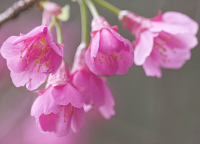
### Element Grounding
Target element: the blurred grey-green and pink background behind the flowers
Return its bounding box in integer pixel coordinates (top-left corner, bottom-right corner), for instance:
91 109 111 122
0 0 200 144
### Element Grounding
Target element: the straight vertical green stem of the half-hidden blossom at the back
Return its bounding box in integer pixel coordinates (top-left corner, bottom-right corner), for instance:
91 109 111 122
80 1 89 45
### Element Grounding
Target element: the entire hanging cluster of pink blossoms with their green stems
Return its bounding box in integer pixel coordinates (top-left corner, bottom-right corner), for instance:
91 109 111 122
1 0 198 137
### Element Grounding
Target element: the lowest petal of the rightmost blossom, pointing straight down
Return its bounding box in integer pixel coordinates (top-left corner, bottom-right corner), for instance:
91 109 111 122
143 56 162 78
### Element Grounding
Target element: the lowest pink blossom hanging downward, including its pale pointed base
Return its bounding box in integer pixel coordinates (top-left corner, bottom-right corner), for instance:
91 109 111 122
31 62 85 137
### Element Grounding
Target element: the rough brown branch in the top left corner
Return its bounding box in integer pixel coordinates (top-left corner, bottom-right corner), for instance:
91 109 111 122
0 0 40 26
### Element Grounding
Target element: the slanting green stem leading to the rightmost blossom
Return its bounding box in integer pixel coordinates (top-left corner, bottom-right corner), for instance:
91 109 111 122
93 0 121 16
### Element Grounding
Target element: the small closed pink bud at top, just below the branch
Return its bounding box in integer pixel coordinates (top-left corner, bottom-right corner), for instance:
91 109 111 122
40 1 62 26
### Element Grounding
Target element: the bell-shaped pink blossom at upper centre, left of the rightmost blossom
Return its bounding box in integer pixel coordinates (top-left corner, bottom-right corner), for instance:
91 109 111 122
85 16 134 76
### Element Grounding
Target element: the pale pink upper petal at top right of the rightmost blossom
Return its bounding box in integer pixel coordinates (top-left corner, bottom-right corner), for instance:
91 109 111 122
162 11 199 35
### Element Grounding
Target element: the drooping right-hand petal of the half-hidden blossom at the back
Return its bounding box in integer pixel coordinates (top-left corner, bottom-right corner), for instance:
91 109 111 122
99 84 115 119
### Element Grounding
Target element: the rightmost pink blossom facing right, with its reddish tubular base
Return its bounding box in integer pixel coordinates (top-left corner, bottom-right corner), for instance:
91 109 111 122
119 11 198 78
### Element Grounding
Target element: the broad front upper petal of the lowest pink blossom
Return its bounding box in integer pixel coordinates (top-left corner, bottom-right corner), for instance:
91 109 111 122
52 83 84 108
